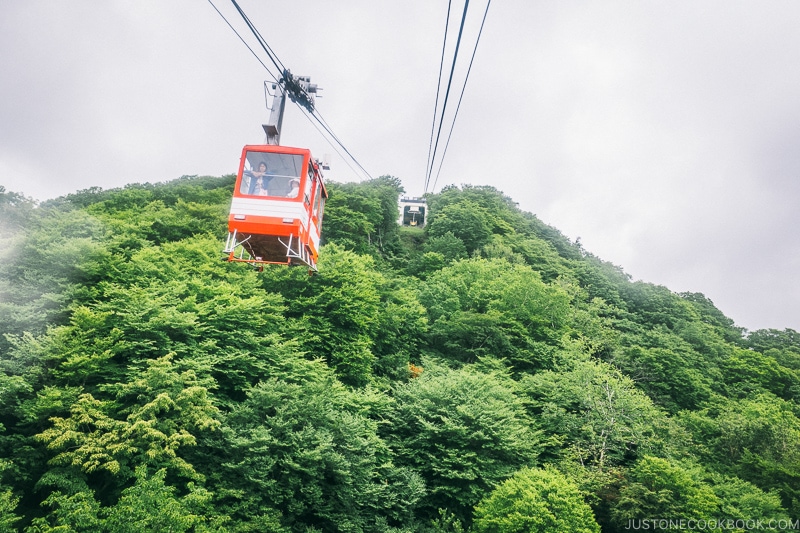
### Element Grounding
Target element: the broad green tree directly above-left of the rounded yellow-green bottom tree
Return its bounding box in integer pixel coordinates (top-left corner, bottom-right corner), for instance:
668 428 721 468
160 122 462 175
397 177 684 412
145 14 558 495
385 360 539 523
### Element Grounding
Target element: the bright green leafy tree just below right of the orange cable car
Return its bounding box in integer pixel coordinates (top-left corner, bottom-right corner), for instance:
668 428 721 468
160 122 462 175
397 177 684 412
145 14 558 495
263 244 428 386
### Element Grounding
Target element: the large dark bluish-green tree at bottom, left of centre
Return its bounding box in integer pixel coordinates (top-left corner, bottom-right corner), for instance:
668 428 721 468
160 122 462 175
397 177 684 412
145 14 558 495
212 370 424 531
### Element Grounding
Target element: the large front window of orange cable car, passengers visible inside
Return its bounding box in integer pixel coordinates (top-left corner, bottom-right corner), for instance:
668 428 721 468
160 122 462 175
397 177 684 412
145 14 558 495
239 152 303 198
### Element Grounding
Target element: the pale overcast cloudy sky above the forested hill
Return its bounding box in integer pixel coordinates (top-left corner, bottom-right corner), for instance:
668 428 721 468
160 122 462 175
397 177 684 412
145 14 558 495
0 0 800 330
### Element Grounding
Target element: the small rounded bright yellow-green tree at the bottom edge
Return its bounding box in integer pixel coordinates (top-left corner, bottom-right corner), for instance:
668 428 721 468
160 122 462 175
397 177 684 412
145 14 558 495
472 468 600 533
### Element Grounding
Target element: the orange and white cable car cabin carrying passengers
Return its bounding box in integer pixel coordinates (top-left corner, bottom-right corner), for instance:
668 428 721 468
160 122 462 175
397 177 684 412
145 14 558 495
225 144 328 272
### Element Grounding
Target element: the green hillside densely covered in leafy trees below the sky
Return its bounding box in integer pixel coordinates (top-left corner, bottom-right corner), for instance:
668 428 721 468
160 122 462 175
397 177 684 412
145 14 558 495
0 176 800 532
